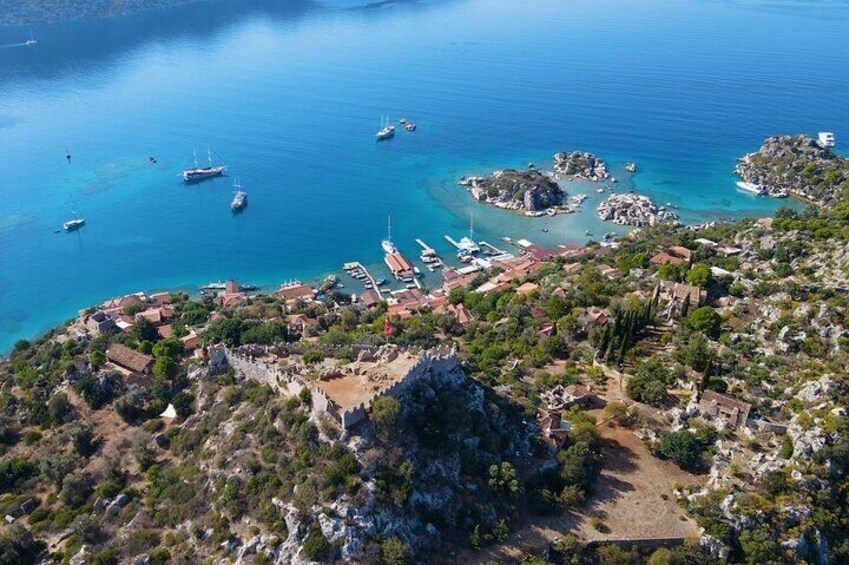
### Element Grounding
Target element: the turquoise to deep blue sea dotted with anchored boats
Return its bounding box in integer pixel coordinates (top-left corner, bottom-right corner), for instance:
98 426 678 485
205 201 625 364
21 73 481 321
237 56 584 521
0 0 849 351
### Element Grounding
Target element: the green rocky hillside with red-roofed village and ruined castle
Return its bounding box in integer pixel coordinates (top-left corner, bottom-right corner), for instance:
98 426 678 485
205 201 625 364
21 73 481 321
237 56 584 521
0 139 849 564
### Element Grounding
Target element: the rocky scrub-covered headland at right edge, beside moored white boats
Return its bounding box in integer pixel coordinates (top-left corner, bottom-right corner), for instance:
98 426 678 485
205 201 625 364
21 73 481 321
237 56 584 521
736 135 849 206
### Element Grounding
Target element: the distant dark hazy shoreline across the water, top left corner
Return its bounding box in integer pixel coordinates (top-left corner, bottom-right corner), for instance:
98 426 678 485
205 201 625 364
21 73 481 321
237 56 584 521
0 0 207 26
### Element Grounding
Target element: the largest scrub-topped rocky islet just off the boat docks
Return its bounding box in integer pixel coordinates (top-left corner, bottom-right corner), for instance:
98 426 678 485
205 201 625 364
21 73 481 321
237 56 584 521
460 169 565 212
